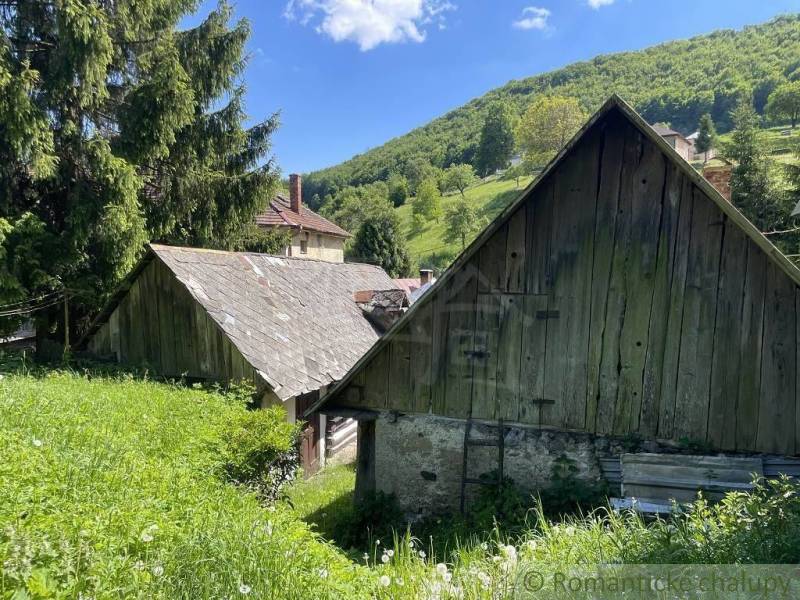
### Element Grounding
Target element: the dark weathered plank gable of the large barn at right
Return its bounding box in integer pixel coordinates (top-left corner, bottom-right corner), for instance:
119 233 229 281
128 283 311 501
336 112 800 455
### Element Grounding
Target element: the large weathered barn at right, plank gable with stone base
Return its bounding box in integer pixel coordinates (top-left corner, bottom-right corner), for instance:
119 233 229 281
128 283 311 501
312 97 800 513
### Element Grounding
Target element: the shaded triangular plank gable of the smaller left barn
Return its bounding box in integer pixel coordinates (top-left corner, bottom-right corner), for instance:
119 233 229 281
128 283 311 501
88 258 258 384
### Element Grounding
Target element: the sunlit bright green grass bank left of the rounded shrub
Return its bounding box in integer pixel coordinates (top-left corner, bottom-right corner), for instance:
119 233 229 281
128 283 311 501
0 374 371 598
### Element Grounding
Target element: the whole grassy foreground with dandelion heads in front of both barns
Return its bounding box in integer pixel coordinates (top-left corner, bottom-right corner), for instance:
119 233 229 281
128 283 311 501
0 370 800 600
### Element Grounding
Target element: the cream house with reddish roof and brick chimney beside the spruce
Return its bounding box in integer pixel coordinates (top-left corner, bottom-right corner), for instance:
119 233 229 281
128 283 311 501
256 175 350 263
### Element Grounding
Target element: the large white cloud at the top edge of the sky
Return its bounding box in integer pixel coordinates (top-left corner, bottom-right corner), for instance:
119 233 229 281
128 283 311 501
283 0 456 51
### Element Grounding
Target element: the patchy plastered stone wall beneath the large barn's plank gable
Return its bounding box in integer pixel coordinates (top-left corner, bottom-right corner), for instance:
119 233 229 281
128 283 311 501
374 412 625 517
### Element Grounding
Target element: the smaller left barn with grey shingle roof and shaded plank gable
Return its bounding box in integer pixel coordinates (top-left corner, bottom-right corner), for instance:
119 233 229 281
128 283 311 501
79 244 396 472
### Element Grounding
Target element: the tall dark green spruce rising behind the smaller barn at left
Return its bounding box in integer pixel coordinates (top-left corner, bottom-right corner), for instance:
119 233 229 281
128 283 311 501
0 0 277 340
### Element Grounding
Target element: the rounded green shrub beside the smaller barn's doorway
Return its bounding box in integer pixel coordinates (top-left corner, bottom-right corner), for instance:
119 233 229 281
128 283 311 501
219 406 300 502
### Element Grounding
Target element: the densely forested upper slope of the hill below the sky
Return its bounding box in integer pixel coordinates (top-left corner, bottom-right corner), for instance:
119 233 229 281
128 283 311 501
304 15 800 202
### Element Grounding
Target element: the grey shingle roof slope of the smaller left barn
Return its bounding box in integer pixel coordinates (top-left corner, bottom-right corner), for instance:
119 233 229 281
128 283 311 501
150 244 396 400
